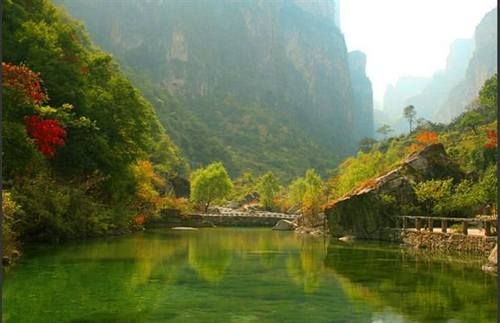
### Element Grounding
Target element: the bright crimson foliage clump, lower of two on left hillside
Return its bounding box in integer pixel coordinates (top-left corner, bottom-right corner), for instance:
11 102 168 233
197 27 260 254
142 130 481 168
26 116 66 158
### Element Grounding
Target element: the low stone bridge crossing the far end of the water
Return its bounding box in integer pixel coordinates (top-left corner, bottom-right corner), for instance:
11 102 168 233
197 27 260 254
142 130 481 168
149 211 298 227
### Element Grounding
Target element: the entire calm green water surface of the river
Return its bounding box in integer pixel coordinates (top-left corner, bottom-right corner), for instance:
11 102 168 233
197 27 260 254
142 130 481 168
3 228 497 322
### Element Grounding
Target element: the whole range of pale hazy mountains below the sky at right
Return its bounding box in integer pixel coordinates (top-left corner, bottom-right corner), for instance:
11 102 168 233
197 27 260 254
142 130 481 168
383 8 497 133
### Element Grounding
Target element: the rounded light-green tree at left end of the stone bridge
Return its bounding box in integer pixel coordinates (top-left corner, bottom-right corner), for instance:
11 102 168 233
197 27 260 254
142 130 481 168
191 162 233 213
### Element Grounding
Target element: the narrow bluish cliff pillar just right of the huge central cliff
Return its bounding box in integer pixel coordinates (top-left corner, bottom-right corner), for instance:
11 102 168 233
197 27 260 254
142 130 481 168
349 51 374 141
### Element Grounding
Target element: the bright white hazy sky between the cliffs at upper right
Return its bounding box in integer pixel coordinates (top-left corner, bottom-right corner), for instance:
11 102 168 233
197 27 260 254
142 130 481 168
340 0 496 102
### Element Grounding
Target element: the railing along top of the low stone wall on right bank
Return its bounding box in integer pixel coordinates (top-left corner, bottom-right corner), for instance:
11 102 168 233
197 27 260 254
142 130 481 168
397 215 497 236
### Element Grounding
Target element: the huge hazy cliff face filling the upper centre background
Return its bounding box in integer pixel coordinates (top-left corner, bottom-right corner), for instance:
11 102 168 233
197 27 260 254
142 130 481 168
58 0 371 177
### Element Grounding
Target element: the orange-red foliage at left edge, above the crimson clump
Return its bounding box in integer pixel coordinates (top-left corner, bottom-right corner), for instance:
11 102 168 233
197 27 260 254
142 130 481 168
2 63 48 104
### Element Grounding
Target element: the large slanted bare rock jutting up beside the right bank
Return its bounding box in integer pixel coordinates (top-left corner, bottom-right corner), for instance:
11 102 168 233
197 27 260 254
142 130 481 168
325 144 463 240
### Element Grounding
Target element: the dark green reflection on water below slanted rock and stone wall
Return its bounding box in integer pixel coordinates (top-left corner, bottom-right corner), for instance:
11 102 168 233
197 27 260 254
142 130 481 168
325 243 497 322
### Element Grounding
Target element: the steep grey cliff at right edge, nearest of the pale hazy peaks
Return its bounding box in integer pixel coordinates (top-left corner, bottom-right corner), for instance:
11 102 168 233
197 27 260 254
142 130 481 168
435 8 498 122
